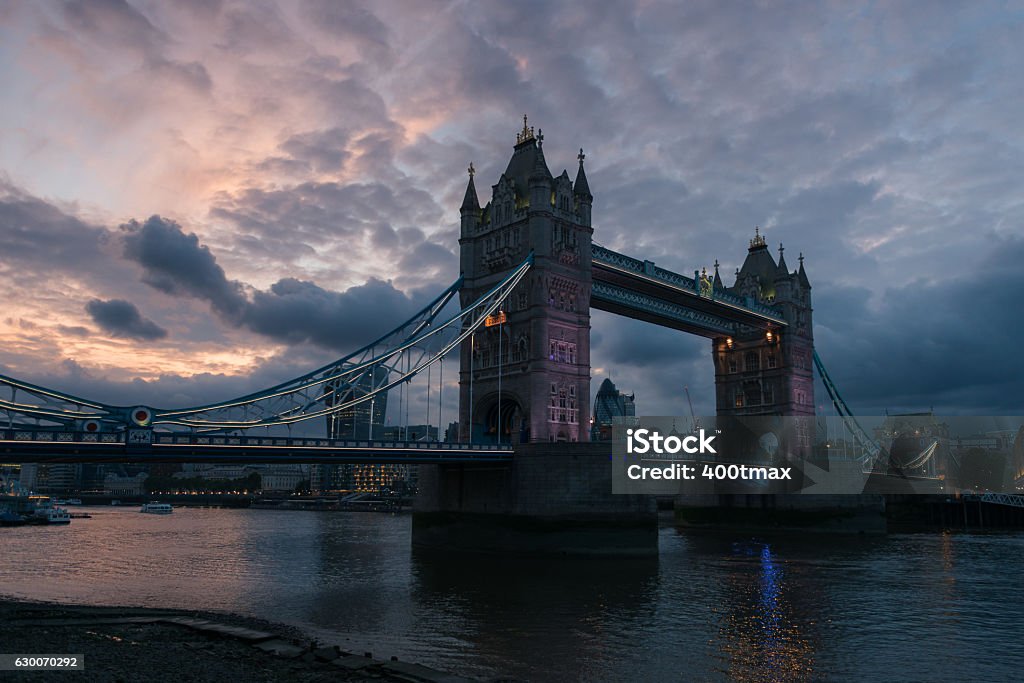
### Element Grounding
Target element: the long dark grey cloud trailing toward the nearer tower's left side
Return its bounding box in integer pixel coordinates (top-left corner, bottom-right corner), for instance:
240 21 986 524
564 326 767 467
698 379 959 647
123 216 426 350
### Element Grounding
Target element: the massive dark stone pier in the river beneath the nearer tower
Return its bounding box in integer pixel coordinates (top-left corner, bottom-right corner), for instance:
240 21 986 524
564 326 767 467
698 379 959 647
413 442 657 556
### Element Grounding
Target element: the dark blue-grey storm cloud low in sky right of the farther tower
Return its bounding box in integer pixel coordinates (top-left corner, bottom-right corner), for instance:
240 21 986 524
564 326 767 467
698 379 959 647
812 238 1024 415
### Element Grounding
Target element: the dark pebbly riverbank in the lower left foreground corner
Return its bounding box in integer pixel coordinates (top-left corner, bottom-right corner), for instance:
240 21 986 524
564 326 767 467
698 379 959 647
0 599 470 683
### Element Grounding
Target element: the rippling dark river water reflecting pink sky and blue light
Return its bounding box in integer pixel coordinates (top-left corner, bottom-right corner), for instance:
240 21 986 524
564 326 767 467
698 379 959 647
0 507 1024 681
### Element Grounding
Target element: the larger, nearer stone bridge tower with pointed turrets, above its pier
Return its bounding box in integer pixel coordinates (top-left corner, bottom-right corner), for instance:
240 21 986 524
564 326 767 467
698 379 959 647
459 117 594 443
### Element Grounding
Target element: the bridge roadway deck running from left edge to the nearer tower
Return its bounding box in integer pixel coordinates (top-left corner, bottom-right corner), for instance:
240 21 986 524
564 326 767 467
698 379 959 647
0 428 512 465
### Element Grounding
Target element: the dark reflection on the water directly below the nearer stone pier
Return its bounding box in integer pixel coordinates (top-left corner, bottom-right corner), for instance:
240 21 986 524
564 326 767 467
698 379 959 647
411 548 658 680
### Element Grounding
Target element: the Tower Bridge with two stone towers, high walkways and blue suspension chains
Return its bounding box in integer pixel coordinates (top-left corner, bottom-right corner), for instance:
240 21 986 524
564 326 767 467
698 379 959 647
0 117 880 547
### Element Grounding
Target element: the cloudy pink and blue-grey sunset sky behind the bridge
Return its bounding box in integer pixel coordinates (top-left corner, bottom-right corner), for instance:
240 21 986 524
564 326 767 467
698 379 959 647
0 0 1024 422
